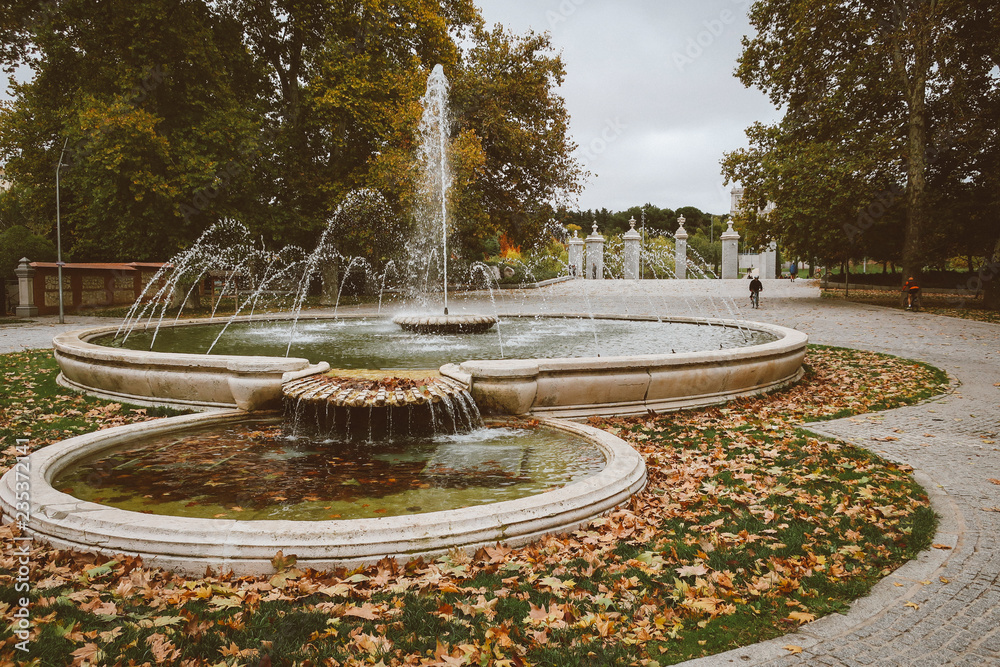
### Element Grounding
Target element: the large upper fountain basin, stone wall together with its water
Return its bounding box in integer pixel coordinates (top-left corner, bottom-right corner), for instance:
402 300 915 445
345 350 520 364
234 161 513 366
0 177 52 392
53 315 807 417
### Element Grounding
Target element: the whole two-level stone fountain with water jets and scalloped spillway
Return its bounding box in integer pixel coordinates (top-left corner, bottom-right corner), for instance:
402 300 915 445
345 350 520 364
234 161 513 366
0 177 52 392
0 68 806 575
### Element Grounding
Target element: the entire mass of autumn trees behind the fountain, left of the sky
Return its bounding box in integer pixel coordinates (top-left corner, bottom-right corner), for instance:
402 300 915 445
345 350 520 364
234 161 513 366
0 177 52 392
0 0 581 261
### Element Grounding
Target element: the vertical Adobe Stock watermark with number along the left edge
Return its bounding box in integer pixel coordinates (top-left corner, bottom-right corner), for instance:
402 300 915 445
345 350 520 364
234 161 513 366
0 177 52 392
11 438 31 653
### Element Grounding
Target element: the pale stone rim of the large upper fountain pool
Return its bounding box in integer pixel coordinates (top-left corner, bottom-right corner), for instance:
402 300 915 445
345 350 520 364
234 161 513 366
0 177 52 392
53 313 808 418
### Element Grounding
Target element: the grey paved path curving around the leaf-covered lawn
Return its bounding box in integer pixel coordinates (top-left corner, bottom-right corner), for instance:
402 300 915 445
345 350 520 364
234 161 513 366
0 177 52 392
0 281 1000 667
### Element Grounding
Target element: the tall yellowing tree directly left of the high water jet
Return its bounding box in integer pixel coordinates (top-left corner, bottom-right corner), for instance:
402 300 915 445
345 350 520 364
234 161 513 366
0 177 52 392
222 0 480 255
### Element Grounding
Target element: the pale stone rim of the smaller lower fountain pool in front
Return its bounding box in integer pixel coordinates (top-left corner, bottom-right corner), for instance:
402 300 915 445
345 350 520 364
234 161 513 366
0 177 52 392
0 411 646 575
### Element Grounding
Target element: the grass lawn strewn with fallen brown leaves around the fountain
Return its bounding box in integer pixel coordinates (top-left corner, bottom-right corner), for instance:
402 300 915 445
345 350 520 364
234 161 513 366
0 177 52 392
0 346 948 667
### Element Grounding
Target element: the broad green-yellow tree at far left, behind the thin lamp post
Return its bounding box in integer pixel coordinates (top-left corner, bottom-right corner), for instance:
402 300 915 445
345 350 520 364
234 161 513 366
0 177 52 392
0 0 253 260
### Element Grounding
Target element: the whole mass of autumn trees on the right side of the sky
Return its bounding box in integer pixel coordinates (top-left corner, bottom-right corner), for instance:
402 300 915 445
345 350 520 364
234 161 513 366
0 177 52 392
723 0 1000 302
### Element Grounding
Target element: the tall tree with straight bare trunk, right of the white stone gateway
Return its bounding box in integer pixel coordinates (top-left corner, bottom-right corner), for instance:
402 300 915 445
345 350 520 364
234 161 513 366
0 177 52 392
723 0 996 290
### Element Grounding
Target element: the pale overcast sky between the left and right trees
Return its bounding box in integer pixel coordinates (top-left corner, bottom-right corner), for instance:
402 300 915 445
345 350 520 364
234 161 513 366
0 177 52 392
477 0 780 213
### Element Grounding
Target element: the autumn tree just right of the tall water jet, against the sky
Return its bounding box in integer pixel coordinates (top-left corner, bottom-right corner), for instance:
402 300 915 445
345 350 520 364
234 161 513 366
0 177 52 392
451 26 583 252
